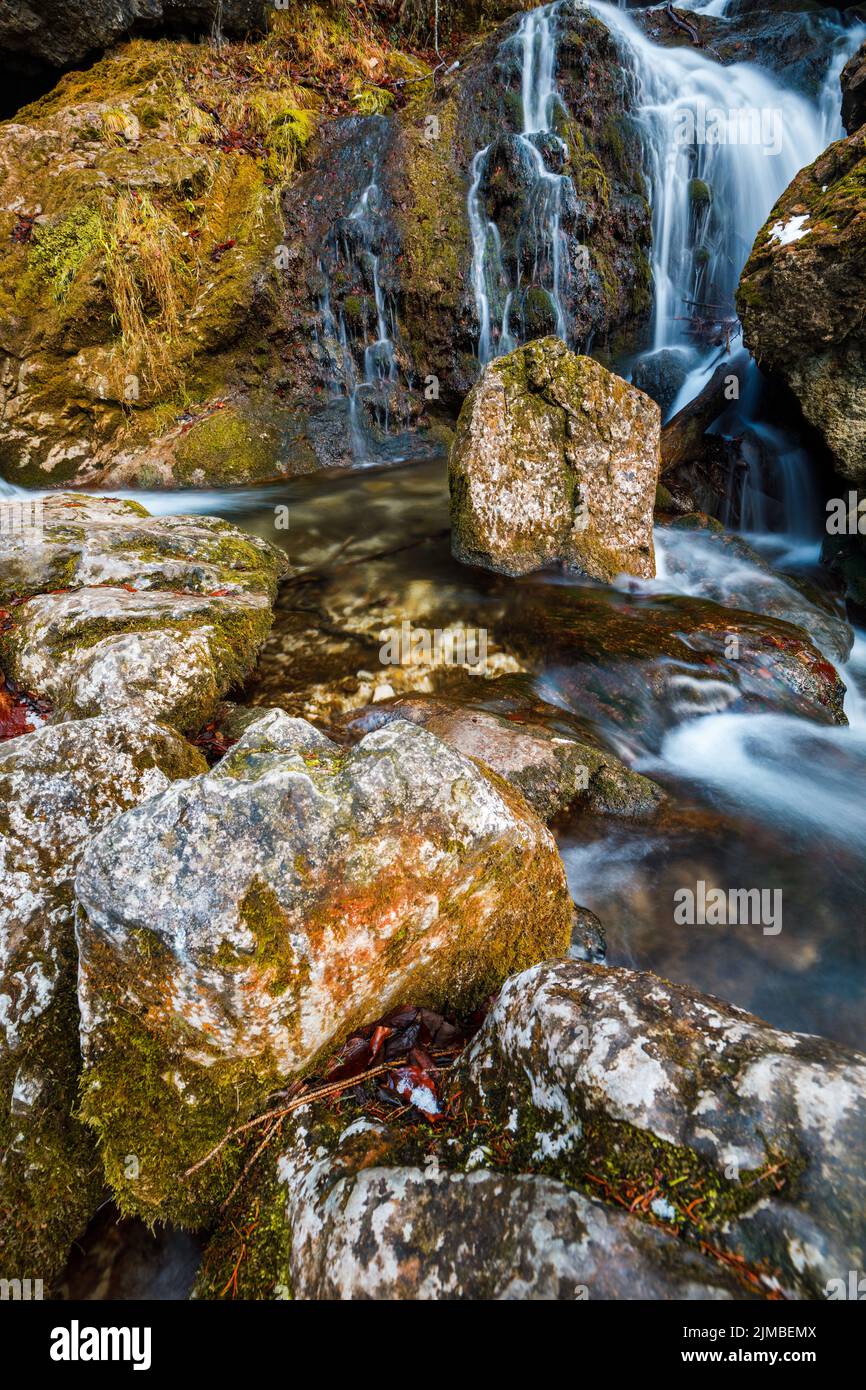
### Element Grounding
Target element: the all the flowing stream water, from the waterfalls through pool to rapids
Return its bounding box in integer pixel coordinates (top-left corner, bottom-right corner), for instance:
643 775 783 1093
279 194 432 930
3 0 866 1047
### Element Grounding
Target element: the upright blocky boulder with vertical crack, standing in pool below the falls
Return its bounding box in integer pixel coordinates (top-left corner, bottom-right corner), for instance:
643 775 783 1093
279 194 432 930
449 338 659 580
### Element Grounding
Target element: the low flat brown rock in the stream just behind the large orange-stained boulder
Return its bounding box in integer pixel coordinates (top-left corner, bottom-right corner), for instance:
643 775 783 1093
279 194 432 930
341 695 663 821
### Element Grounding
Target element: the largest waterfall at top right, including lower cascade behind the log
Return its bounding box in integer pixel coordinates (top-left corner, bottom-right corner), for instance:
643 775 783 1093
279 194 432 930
585 0 866 534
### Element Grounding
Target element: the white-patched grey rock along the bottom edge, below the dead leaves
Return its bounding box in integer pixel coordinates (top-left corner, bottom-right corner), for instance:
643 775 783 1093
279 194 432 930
197 1116 744 1301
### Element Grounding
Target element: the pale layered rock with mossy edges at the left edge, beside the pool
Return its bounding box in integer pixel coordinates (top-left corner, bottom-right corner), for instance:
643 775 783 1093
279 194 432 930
0 496 286 730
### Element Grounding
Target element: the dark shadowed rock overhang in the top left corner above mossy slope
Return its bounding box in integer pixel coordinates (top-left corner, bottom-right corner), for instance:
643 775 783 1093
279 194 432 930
0 0 268 71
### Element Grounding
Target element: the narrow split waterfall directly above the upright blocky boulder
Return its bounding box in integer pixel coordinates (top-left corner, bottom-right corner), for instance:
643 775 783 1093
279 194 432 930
467 0 569 366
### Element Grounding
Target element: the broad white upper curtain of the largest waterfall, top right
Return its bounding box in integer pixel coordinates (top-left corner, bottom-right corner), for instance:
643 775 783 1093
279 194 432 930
588 0 838 358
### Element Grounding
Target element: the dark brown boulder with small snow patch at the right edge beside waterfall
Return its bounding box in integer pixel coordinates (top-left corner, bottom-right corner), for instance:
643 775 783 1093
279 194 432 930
737 135 866 482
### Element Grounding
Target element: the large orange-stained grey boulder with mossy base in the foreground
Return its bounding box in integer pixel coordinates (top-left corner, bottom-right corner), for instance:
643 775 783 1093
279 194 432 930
76 712 571 1225
